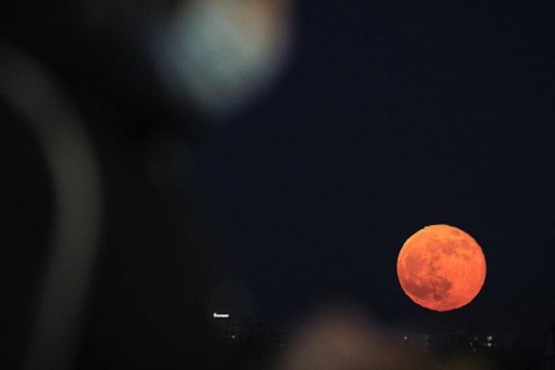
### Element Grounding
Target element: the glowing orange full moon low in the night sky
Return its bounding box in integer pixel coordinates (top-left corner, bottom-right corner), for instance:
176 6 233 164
397 225 486 312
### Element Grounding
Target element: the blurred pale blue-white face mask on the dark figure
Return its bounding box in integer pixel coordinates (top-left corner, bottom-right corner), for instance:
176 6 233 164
151 0 296 116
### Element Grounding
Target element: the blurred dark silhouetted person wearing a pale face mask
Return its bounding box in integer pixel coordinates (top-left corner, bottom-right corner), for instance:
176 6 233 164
0 0 294 370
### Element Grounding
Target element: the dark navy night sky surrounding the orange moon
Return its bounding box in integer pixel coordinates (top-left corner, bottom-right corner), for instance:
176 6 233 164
192 0 555 342
